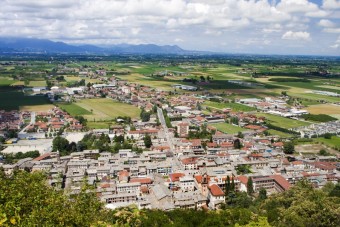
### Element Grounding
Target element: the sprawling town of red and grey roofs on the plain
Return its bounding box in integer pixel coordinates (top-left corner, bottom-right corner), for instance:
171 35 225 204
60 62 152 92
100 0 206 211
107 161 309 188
0 56 340 210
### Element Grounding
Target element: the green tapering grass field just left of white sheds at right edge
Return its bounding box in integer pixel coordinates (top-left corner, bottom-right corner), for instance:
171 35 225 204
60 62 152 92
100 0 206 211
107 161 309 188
256 113 310 129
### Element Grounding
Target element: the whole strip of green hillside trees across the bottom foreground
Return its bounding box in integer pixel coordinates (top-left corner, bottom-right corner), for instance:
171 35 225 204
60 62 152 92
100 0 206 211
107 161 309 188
0 171 340 227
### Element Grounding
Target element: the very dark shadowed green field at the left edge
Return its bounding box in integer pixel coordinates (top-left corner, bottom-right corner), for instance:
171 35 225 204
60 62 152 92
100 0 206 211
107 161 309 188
0 88 50 110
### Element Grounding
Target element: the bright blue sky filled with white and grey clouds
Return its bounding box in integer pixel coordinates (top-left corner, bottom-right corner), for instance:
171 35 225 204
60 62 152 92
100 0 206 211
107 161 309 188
0 0 340 55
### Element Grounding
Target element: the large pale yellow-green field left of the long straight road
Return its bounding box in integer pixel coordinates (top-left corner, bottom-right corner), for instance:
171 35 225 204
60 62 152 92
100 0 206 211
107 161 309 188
74 98 140 121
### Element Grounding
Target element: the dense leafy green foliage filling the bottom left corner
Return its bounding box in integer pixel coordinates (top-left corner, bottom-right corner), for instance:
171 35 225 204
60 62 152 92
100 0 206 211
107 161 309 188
0 171 108 226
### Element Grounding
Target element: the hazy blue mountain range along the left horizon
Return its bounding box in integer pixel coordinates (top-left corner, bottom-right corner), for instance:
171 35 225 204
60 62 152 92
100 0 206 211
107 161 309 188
0 38 202 54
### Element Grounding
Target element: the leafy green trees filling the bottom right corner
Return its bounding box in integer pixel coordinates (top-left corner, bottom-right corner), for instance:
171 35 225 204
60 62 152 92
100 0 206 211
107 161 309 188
260 180 340 226
